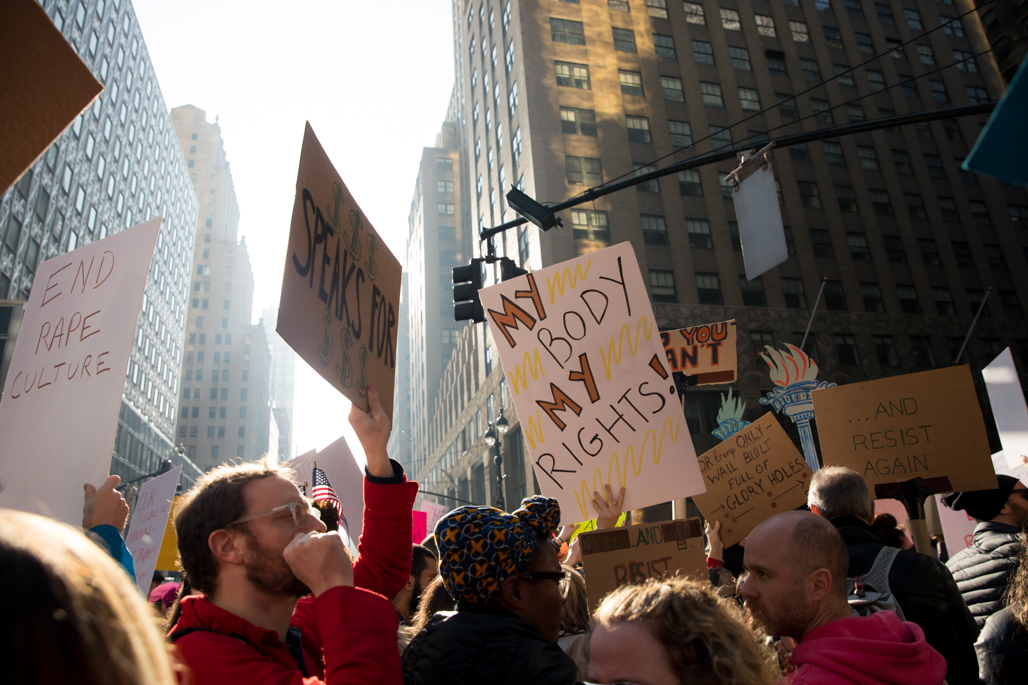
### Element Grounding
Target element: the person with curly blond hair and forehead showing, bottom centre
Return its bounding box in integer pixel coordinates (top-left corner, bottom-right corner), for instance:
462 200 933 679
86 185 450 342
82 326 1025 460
589 578 779 685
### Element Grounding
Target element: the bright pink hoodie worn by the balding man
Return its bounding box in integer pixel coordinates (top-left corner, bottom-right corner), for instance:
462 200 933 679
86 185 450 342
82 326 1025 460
779 611 946 685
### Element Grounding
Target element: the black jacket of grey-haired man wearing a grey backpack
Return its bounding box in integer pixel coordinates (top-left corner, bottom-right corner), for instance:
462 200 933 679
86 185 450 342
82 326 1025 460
832 516 979 685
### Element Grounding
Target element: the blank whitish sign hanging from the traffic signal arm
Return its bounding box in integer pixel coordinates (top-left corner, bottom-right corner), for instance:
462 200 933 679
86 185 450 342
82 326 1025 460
732 157 788 281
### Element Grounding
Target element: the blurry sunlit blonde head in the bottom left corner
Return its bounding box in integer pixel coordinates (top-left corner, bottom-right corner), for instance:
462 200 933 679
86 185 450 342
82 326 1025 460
0 509 177 685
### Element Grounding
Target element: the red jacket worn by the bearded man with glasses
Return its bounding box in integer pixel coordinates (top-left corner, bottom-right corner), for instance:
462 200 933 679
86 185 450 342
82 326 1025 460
170 475 417 685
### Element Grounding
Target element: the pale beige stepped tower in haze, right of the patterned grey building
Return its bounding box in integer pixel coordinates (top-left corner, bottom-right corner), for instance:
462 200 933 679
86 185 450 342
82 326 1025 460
172 105 279 469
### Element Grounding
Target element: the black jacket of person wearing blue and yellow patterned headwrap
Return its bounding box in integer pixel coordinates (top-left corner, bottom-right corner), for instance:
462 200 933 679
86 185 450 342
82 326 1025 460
402 605 578 685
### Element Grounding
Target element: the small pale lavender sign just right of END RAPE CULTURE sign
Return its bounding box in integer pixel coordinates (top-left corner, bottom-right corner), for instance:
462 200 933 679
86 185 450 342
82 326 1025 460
125 466 182 597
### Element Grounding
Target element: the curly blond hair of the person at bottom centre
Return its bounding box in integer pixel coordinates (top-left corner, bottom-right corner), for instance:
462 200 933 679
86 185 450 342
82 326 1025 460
593 577 778 685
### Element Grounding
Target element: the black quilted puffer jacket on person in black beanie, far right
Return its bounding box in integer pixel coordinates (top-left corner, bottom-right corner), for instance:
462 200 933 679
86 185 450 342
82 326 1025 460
946 521 1021 628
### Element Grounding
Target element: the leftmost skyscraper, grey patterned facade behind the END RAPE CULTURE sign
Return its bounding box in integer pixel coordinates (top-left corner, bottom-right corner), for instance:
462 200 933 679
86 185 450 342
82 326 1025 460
0 0 199 486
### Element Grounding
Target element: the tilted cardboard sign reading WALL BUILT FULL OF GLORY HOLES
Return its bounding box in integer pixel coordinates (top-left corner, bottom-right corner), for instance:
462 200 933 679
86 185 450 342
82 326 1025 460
693 411 810 547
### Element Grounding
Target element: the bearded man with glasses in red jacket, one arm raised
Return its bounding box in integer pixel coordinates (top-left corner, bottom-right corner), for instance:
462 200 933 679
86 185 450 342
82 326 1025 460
169 387 417 685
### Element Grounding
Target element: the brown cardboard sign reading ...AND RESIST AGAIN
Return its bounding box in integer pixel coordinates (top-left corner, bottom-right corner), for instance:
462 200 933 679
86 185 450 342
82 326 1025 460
811 366 997 499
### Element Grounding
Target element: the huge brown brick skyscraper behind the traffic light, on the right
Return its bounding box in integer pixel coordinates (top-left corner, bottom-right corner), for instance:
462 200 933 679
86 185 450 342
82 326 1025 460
411 0 1028 505
